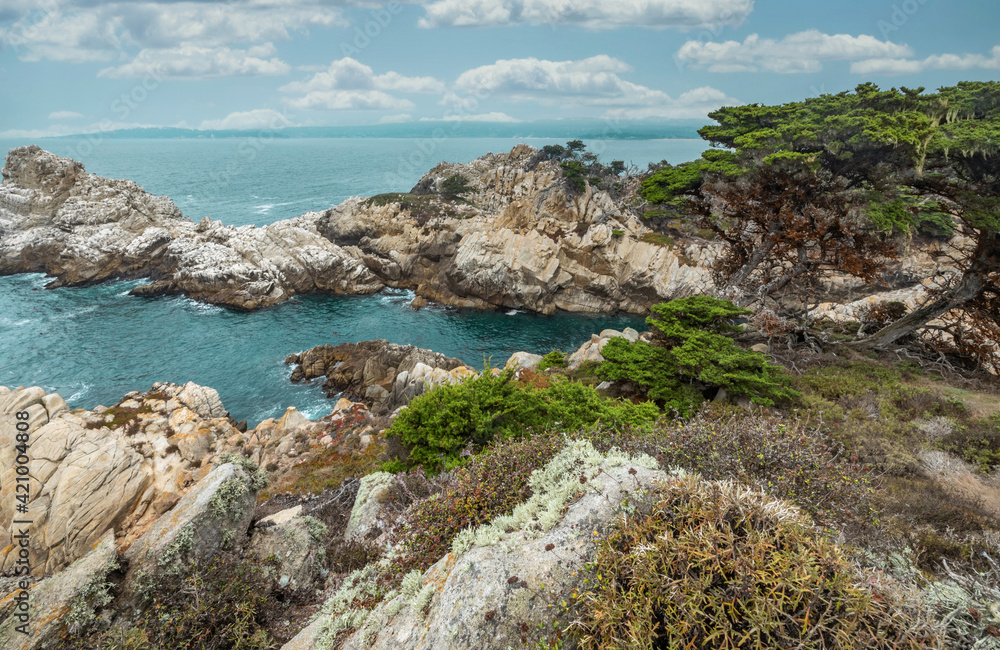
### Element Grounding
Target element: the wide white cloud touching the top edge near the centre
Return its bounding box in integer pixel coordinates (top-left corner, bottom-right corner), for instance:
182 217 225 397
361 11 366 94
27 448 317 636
418 0 754 29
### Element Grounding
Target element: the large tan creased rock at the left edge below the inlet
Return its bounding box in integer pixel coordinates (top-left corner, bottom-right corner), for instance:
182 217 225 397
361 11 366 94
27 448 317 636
0 384 250 575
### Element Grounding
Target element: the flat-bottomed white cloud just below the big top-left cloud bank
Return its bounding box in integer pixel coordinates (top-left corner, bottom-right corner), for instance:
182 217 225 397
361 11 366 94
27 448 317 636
97 43 292 79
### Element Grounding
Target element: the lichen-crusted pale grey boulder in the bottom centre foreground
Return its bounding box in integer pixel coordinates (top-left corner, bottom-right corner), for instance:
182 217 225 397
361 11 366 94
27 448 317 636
284 441 669 650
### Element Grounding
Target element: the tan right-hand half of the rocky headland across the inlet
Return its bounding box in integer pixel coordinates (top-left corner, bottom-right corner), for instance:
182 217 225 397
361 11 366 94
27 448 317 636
316 145 715 313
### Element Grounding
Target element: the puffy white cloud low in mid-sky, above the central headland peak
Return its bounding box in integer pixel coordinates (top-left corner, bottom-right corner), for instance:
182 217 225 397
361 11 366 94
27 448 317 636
454 54 670 106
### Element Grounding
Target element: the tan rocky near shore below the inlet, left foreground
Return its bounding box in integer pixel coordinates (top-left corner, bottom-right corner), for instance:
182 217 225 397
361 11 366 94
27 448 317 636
0 330 637 649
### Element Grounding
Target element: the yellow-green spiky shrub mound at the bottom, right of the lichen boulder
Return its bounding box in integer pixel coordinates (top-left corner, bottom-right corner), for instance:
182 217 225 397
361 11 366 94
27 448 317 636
570 475 935 650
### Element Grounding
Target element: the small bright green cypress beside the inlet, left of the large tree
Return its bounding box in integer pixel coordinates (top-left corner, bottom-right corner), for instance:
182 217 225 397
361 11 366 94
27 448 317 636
598 296 797 415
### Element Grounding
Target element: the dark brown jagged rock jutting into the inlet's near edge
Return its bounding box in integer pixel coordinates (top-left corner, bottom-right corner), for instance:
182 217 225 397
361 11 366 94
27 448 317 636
286 339 474 414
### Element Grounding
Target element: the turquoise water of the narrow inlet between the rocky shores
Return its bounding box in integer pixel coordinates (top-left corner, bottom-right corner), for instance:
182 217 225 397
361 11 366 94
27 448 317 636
0 274 642 424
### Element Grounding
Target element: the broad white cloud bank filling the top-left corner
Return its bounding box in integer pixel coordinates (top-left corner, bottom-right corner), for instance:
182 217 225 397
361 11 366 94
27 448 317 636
0 0 346 62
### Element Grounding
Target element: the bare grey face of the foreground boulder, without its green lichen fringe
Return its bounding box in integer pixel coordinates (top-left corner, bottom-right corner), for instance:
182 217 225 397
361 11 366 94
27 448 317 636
326 448 668 650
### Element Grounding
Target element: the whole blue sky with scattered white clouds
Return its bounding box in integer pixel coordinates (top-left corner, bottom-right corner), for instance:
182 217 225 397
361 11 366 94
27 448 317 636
0 0 1000 137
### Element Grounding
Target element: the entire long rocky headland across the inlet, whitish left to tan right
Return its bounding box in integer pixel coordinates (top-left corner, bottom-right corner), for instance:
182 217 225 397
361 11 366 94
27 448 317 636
0 145 714 313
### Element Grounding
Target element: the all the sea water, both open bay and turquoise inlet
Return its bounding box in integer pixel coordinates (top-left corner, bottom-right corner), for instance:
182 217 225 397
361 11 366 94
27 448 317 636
0 138 705 426
